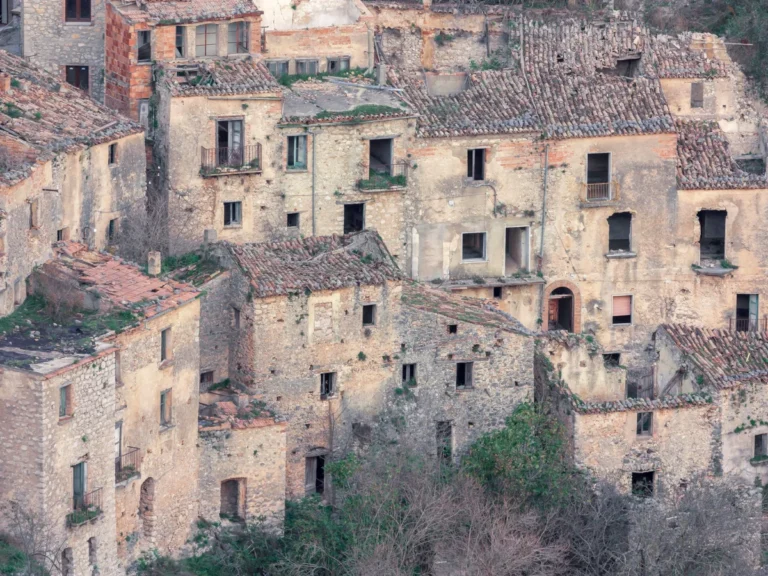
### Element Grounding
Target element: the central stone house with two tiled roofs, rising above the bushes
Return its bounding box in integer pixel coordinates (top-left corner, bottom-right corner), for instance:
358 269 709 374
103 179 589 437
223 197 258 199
201 231 533 498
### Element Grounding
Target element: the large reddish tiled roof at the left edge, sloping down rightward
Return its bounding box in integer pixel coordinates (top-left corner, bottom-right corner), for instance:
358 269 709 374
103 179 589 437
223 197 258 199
0 50 143 182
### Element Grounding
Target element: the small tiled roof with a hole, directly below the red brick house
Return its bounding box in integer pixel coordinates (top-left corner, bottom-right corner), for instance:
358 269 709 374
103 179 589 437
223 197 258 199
161 56 282 96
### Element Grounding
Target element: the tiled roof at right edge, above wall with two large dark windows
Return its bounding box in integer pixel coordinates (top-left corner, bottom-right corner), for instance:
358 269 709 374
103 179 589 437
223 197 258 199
675 120 768 190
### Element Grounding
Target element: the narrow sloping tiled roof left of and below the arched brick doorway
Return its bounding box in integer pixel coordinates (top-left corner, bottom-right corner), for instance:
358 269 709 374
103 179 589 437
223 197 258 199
402 282 530 335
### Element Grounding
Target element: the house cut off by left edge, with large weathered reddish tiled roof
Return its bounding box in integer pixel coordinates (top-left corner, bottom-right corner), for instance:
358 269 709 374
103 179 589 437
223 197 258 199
0 51 146 314
